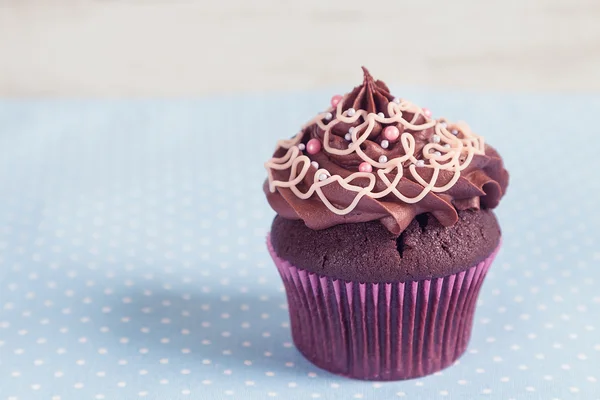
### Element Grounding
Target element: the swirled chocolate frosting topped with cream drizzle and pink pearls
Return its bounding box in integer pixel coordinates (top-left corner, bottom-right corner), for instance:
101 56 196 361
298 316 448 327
264 68 508 234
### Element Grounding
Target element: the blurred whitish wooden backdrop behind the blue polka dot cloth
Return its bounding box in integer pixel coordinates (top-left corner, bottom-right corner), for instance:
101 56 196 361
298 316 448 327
0 0 600 96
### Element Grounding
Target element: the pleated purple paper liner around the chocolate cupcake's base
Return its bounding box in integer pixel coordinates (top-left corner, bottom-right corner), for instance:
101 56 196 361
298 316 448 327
267 236 500 380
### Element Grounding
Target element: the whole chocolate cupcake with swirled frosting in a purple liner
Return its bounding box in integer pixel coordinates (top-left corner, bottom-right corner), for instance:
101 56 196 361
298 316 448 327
263 68 508 380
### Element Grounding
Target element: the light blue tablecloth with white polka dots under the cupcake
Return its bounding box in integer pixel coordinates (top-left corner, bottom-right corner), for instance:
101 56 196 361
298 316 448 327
0 89 600 400
